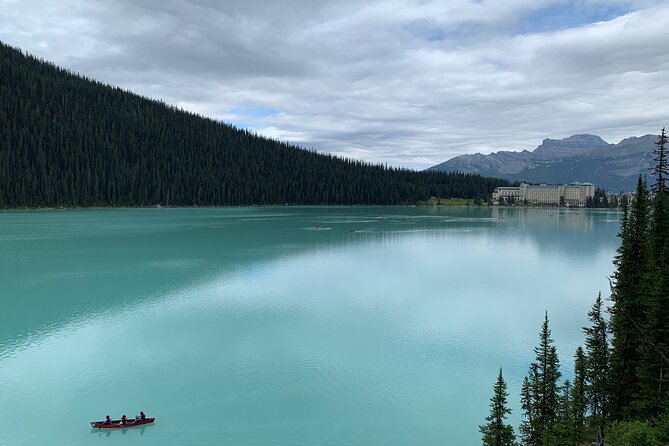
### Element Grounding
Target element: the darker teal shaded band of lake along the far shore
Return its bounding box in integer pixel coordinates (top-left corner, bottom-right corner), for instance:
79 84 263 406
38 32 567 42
0 207 618 358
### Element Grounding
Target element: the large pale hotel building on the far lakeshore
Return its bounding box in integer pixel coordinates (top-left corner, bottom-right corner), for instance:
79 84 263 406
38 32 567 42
492 183 595 208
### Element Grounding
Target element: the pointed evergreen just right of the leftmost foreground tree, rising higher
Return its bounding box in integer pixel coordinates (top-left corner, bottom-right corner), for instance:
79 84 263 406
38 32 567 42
521 313 561 446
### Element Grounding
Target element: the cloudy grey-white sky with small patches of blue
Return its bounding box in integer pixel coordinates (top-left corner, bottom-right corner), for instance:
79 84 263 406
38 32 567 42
0 0 669 169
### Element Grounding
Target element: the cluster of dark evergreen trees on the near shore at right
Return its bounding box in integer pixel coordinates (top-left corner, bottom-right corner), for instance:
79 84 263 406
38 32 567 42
480 128 669 446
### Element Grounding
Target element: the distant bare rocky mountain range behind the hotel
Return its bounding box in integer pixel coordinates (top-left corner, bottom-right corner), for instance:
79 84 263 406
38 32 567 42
427 134 657 192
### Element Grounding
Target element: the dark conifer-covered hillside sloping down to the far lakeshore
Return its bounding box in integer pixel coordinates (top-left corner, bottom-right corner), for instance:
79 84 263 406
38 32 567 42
0 42 506 208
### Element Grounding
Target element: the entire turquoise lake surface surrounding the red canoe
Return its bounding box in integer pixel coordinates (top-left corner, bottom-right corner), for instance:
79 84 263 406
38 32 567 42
0 207 619 446
